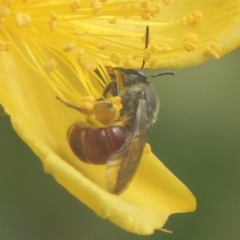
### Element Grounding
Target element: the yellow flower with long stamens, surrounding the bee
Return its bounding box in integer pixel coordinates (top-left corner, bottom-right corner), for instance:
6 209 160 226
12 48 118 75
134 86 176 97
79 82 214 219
0 0 240 234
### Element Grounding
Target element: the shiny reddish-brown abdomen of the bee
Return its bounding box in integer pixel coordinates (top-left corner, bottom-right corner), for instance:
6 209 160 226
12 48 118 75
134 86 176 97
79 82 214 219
68 123 126 165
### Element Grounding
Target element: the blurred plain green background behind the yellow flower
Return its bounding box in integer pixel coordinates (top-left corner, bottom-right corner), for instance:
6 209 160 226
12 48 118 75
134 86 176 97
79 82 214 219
0 50 240 240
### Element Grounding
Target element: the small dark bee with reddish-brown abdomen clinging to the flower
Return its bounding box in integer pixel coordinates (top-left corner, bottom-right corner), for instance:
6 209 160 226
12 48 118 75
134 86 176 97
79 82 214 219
58 27 174 195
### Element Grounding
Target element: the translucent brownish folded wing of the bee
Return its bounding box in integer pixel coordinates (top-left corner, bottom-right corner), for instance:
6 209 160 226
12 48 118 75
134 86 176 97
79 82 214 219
106 98 152 194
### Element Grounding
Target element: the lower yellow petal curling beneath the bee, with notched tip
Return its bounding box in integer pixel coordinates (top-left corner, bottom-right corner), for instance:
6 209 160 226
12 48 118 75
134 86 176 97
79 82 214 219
0 48 196 234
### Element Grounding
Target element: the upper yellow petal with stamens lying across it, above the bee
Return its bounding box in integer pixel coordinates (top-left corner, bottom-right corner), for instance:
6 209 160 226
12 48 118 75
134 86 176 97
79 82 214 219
0 0 240 70
